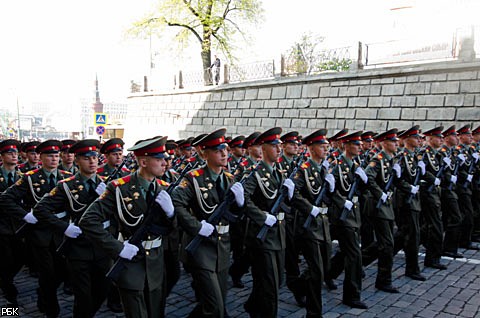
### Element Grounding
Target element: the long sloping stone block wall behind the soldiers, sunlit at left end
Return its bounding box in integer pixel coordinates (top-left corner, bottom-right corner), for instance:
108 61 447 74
125 60 480 144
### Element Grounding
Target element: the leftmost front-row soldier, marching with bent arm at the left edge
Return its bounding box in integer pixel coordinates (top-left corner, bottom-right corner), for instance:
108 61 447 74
0 140 70 317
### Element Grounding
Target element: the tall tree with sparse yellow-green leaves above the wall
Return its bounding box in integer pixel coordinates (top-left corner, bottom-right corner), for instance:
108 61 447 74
129 0 263 84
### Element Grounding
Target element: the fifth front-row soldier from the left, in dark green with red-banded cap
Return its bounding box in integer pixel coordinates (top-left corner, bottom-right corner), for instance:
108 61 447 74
244 127 295 318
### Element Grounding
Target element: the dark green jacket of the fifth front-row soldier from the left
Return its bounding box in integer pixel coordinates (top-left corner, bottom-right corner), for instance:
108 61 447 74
244 161 288 251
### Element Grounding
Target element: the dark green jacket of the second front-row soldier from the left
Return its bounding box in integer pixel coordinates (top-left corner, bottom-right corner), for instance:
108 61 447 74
33 172 106 261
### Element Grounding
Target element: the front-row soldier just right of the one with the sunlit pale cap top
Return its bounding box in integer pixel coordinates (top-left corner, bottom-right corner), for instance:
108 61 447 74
172 129 245 318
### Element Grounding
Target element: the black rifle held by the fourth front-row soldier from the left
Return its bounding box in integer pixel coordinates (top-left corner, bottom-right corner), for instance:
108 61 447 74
185 164 260 255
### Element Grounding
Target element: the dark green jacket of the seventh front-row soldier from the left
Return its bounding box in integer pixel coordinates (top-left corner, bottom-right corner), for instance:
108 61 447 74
328 154 363 229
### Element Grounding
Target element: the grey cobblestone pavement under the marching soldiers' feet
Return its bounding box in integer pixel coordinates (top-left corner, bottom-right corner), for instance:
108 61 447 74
0 249 480 318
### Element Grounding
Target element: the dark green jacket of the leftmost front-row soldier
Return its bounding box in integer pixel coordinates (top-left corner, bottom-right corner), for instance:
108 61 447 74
0 168 71 247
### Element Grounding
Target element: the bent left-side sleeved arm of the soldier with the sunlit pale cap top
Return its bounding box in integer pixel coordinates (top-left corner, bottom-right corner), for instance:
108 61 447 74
79 183 123 259
